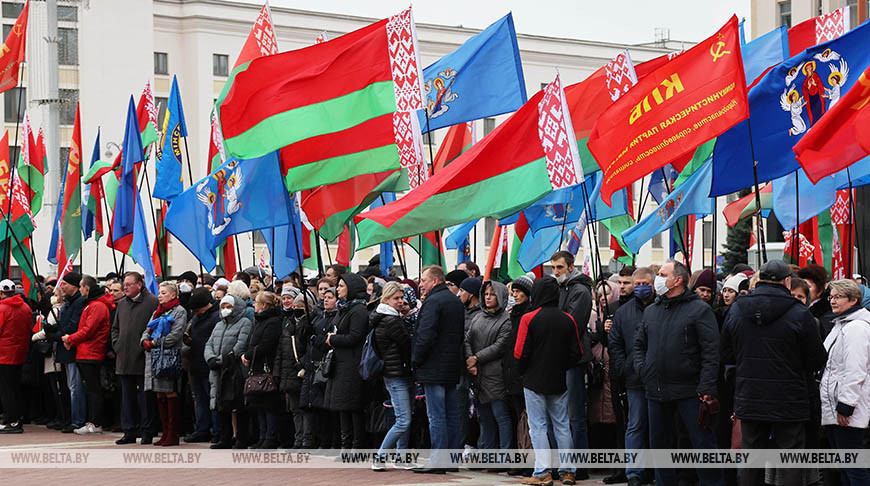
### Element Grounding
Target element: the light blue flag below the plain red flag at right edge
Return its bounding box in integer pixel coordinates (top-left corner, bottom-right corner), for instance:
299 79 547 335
772 157 870 230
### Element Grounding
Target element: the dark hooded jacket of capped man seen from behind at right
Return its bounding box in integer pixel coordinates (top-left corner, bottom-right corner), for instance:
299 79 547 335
720 282 826 422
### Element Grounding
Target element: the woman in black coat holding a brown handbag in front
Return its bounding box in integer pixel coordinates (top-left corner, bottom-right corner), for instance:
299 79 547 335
242 291 282 449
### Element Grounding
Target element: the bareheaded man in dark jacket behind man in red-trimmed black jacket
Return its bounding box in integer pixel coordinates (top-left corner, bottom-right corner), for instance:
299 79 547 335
550 251 592 460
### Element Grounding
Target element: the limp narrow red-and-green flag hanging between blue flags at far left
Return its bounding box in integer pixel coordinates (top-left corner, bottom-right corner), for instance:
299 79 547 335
60 105 82 258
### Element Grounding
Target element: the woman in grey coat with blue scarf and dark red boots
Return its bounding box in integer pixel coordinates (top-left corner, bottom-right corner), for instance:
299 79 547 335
140 282 187 446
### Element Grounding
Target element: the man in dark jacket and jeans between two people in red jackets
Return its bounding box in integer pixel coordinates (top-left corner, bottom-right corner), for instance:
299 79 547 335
46 272 87 434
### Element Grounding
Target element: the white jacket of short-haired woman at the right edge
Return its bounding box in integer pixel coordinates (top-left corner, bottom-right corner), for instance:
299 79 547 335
819 304 870 429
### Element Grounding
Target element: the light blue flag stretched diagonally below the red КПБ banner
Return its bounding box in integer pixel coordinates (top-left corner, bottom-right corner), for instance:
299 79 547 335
622 160 713 254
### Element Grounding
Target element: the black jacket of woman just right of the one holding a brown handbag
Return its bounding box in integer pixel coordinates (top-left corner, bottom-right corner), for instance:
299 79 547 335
272 309 316 393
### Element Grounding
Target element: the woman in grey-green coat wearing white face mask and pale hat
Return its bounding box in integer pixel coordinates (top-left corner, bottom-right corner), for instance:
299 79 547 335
203 295 251 449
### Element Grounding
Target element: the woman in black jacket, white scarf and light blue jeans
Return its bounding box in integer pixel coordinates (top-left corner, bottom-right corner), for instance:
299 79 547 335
370 282 414 471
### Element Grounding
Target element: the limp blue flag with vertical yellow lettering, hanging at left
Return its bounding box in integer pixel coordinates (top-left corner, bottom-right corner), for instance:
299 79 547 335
154 76 187 201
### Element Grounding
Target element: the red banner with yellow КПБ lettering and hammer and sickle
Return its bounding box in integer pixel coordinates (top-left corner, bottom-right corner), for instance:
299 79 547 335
588 16 749 204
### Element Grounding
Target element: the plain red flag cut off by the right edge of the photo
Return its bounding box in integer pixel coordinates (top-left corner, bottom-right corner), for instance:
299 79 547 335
793 67 870 184
